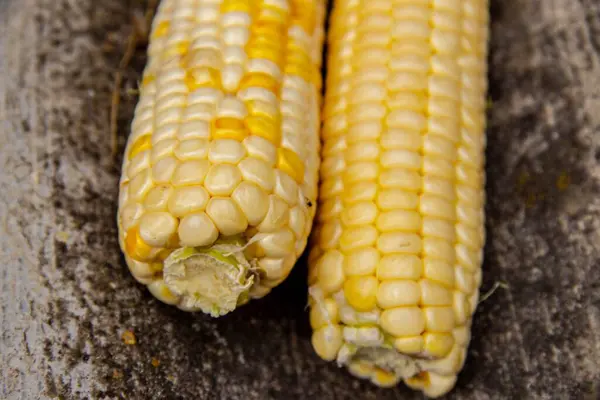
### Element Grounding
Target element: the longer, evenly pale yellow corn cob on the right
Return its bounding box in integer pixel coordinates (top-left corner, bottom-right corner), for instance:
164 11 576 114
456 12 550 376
309 0 488 397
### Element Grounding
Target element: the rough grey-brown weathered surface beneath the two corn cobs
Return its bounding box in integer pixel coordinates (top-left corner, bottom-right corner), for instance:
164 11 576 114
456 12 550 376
0 0 600 400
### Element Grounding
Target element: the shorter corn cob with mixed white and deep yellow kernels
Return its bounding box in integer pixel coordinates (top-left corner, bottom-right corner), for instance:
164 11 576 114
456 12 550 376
118 0 325 316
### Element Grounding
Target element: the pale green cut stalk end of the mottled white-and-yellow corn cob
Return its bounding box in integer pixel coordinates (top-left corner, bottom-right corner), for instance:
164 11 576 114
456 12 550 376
163 244 254 317
